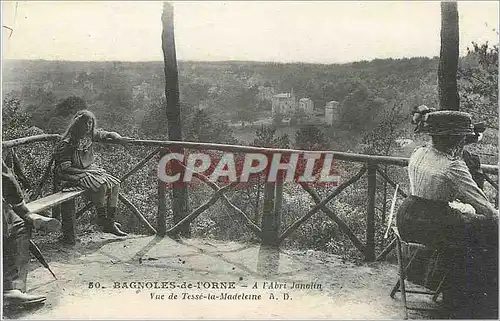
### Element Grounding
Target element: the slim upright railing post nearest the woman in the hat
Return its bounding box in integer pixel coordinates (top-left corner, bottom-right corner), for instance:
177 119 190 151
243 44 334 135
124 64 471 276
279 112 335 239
365 163 377 261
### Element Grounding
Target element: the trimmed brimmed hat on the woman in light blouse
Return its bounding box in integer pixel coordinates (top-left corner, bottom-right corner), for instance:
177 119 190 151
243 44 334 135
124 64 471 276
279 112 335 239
412 105 476 136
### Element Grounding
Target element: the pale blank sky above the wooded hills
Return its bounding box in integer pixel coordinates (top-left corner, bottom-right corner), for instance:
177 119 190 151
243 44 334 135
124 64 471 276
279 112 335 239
2 1 499 64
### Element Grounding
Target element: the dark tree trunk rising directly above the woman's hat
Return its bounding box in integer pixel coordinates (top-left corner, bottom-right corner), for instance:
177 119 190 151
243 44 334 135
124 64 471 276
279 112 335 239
438 2 460 110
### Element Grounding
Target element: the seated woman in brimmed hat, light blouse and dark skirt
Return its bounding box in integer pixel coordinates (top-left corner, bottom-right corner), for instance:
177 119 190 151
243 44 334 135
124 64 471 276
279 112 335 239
397 106 498 318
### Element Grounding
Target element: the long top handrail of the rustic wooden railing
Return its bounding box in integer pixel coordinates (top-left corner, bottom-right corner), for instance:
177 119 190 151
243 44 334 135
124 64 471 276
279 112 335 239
2 134 498 174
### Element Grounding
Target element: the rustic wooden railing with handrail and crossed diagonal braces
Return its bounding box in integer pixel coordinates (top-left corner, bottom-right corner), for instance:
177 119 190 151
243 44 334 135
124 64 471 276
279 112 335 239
2 135 498 261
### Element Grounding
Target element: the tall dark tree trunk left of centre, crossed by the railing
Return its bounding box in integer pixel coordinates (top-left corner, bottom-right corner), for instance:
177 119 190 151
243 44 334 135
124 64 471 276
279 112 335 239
160 2 190 237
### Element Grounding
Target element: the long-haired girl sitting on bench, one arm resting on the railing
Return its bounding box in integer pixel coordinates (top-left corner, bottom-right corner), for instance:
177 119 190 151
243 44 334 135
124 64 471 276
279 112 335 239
54 110 127 236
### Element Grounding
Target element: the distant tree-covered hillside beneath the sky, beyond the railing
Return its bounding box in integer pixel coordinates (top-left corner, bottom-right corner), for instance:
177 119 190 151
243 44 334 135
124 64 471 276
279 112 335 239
3 58 437 139
